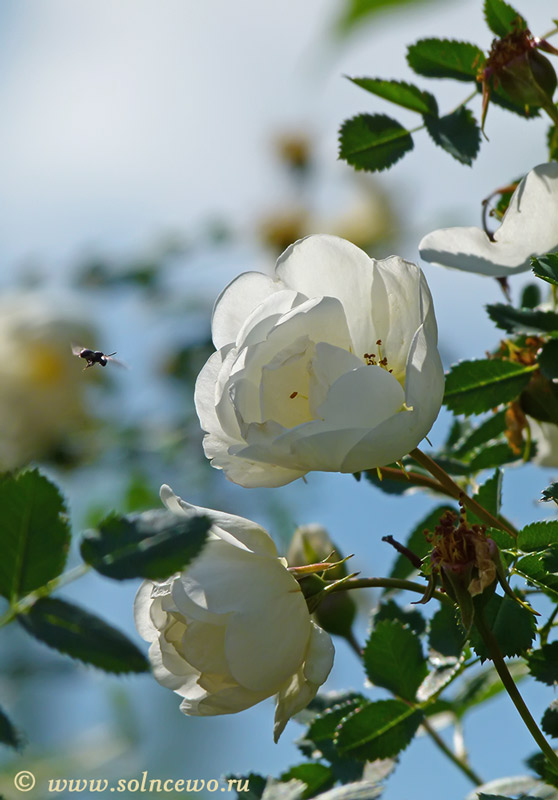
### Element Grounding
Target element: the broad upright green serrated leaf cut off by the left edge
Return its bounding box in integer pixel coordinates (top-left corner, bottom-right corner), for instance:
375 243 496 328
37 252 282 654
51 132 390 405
0 469 70 601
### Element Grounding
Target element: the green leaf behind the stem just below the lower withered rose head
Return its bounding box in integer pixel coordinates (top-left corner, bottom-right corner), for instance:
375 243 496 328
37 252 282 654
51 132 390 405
471 594 535 659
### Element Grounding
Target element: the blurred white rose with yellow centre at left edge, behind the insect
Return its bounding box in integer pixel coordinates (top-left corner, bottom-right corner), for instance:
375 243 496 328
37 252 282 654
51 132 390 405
0 292 91 470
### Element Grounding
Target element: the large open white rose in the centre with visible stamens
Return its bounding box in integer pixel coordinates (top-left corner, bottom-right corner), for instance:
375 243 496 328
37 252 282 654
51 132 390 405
195 235 444 487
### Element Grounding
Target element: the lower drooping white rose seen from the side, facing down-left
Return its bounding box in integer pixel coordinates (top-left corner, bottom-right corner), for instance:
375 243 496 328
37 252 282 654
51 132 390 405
134 486 334 741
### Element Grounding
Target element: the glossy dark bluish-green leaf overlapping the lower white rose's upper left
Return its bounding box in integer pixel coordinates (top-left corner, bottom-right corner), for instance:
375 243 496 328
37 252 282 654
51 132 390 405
81 510 211 580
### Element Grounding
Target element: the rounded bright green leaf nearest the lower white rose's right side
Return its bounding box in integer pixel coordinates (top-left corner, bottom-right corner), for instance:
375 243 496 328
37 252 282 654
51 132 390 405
363 620 428 701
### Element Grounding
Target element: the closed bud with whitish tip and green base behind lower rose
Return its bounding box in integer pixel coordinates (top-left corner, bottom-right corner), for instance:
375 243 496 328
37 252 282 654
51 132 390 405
287 523 357 637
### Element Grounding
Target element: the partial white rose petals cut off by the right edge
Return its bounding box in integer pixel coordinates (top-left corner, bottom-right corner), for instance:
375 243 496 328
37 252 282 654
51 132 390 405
419 161 558 278
